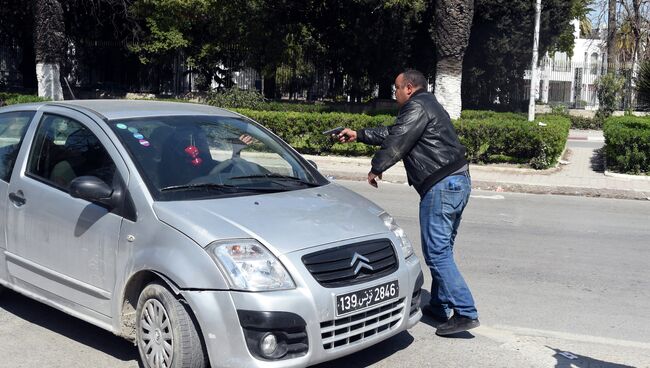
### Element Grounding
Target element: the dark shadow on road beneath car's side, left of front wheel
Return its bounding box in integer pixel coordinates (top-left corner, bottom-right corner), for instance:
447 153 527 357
0 290 141 366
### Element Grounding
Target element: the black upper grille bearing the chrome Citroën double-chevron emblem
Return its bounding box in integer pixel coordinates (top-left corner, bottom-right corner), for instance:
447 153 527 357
302 239 399 288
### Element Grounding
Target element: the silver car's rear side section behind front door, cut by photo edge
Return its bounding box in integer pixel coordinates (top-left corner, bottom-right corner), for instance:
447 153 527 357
0 111 36 281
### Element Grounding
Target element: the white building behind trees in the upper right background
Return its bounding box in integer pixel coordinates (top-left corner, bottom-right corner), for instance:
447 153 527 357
524 20 607 109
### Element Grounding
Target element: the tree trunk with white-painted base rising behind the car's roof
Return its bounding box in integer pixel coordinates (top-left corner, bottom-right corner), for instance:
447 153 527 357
34 0 66 101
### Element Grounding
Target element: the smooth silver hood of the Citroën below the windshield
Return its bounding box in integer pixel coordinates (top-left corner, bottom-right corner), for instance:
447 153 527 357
153 183 388 254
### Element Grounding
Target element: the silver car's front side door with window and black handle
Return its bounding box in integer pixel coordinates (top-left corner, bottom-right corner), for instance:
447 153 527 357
6 106 128 317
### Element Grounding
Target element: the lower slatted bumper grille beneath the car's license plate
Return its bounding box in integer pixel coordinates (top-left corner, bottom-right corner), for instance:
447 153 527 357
320 298 404 350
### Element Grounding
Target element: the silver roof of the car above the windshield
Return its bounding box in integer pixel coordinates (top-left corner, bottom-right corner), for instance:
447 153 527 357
2 100 240 120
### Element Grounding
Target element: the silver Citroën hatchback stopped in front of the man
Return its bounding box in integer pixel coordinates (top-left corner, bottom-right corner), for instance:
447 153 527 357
0 100 423 368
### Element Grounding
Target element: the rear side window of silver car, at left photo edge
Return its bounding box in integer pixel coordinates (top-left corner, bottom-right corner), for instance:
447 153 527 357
0 111 36 182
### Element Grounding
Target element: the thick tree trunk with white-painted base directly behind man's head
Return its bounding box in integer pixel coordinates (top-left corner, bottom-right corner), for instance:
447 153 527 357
434 0 474 119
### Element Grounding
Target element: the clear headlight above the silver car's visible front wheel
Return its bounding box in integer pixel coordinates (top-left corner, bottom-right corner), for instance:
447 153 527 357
207 239 296 291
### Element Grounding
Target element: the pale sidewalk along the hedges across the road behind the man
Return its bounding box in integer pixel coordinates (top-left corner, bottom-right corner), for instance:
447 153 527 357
305 130 650 200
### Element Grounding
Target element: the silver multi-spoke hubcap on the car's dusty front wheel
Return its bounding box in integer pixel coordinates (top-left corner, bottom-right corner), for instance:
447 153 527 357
138 299 174 368
